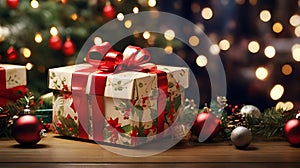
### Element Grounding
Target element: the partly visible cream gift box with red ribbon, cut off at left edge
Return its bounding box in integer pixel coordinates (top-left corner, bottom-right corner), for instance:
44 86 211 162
0 64 28 106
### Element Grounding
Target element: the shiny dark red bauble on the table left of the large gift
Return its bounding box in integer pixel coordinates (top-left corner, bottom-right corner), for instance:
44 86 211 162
12 115 43 146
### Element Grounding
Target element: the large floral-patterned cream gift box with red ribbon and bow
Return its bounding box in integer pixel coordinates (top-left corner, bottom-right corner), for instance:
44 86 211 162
49 42 189 146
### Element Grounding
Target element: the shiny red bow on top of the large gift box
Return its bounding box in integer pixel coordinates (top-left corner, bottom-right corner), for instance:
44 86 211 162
86 42 156 72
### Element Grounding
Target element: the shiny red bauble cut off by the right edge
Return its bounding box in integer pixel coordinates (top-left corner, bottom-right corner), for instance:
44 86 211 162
284 113 300 146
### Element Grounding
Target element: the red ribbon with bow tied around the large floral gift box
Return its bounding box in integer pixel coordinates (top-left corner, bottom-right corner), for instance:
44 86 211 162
72 42 168 141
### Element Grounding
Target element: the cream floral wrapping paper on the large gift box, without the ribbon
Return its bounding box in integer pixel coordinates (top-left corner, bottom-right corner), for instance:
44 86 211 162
49 64 189 146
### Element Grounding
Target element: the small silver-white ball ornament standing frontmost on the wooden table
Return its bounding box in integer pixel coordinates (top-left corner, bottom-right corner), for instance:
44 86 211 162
230 126 252 148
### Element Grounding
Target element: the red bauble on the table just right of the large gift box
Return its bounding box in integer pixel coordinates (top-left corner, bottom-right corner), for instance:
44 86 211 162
192 112 221 142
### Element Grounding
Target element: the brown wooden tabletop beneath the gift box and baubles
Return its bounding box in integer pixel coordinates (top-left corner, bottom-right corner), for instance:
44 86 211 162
0 133 300 168
